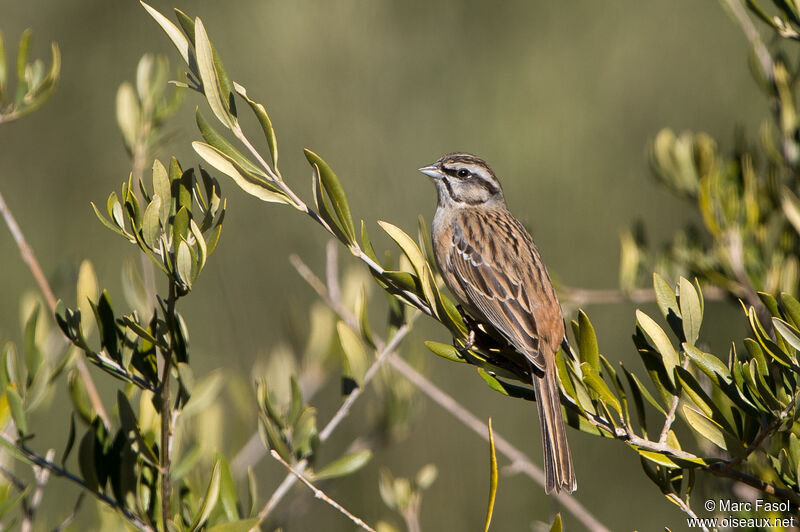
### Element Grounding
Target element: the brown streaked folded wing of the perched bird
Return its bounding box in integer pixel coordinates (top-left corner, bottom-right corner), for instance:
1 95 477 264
448 213 548 370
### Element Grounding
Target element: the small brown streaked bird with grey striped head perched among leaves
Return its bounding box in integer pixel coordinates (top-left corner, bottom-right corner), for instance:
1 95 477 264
419 153 577 494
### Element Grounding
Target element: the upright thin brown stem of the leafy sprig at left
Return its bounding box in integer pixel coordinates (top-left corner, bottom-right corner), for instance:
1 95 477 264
159 279 177 531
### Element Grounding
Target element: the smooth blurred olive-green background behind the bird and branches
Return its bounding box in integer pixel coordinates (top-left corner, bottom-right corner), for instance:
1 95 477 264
0 0 767 531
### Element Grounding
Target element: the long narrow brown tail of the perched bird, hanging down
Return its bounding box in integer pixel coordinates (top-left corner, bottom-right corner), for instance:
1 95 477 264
532 357 577 493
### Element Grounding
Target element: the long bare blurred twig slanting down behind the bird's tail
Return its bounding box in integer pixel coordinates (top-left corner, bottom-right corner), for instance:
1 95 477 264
289 255 608 532
